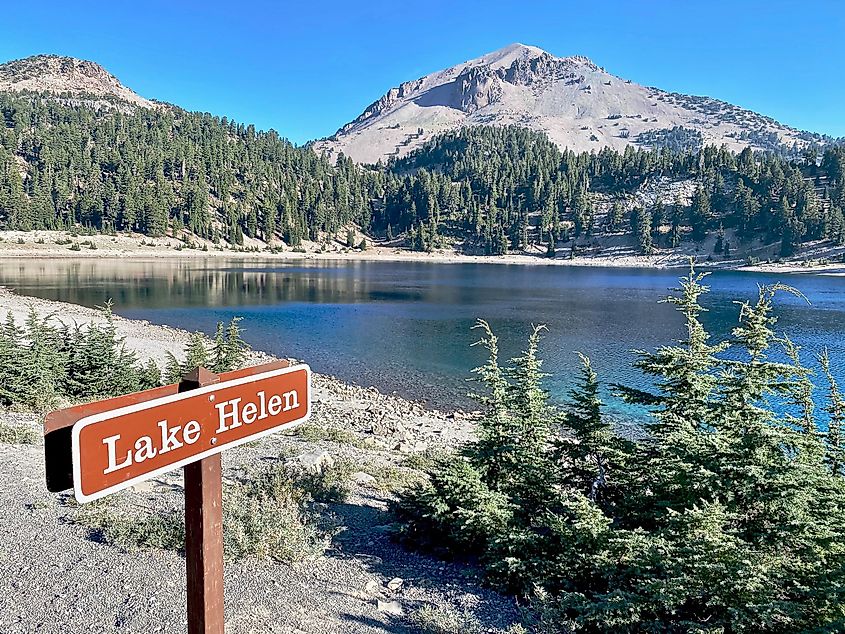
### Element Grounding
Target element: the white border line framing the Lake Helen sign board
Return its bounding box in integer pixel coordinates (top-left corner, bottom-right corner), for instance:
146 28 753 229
71 363 311 504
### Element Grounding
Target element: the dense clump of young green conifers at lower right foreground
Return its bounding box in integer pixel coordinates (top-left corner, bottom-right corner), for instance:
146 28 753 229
394 262 845 633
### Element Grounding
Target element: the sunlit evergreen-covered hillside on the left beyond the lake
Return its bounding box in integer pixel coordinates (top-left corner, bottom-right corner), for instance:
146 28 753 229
0 93 380 245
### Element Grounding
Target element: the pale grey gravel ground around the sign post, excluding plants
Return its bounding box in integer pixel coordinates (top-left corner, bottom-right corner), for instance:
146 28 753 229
0 289 517 634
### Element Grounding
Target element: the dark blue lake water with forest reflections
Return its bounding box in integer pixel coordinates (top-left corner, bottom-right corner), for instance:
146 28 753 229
0 258 845 413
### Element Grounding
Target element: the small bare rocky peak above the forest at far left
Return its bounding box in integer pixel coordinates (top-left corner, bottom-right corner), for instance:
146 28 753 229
0 55 156 108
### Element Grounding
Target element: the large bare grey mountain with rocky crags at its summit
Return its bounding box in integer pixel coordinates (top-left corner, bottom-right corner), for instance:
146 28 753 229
314 44 823 163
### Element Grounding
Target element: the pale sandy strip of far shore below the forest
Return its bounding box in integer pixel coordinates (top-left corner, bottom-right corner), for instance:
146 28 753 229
0 231 845 275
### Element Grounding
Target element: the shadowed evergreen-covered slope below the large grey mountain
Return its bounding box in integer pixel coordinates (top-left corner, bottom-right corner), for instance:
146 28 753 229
390 127 845 256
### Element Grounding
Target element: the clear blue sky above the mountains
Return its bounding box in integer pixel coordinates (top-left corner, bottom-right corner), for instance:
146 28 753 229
0 0 845 143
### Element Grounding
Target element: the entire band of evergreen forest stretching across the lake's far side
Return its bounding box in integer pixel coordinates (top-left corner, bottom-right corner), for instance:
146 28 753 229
0 86 845 255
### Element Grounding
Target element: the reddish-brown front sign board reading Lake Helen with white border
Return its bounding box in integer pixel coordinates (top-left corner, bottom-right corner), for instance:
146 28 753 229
71 365 311 503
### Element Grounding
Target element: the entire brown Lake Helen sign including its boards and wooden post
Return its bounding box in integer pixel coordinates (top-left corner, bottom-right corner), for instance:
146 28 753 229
44 361 311 634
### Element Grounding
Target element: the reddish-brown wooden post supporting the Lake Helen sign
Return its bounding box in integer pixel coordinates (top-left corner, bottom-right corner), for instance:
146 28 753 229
179 368 225 634
